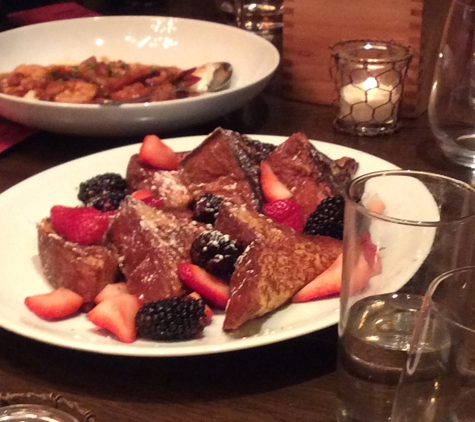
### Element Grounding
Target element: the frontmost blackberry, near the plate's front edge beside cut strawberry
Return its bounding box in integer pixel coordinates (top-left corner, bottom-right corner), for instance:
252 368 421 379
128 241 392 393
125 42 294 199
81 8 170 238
135 296 206 341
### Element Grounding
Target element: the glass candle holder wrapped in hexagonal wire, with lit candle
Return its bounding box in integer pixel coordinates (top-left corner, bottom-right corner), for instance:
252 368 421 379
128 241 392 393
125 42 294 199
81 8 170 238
330 40 412 136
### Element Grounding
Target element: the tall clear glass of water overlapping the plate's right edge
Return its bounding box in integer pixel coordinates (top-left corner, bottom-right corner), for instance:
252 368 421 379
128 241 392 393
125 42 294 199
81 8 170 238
337 170 475 422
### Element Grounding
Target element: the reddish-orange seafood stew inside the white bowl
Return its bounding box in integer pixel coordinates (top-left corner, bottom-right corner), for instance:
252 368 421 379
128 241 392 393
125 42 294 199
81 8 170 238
0 56 225 104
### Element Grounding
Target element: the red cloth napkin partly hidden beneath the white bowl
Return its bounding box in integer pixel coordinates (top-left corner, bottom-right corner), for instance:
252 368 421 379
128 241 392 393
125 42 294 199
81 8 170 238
0 2 100 153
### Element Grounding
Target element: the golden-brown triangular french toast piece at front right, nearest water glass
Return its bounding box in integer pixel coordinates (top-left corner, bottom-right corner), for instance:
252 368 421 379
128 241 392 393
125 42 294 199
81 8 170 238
215 202 343 330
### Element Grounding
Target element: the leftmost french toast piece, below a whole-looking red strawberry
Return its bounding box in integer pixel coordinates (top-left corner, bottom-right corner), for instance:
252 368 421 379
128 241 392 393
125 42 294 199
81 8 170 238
37 218 119 306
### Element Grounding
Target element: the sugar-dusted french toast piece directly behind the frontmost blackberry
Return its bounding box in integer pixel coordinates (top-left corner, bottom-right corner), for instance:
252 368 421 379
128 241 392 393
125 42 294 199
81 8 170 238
110 197 206 303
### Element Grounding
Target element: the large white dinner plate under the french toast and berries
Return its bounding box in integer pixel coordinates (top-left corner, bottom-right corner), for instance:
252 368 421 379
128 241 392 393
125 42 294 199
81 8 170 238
0 135 407 356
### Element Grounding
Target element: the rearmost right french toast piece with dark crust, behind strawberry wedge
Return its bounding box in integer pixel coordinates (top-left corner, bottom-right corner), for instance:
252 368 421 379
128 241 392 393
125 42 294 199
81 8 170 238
268 133 358 221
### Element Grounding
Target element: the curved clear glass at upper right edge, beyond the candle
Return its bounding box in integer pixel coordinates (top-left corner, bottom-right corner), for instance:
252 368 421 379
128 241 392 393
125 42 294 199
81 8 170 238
429 0 475 168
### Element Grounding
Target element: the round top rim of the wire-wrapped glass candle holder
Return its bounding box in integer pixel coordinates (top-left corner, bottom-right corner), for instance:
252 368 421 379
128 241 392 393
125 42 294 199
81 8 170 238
330 39 413 64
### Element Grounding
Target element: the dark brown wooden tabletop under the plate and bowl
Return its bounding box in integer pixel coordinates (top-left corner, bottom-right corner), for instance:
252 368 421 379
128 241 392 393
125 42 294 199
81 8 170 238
0 0 473 422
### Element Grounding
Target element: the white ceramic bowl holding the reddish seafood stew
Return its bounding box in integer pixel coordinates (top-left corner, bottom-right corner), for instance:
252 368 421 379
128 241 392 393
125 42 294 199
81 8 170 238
0 16 280 136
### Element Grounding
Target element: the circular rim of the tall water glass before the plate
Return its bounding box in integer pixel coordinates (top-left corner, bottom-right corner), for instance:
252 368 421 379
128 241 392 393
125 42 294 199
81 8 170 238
343 169 475 227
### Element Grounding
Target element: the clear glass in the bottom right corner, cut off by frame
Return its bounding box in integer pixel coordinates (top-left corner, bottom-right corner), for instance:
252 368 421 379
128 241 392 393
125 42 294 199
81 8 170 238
391 266 475 422
